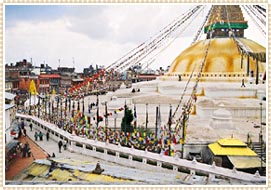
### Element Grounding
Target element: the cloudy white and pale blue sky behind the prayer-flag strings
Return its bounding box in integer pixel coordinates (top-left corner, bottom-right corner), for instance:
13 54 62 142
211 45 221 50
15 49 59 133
4 3 265 72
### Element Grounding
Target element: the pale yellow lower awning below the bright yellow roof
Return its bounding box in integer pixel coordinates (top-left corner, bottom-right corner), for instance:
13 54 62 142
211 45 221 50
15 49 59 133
228 156 265 169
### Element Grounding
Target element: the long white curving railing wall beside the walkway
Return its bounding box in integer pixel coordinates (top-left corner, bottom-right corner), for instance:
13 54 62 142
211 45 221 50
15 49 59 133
16 113 266 183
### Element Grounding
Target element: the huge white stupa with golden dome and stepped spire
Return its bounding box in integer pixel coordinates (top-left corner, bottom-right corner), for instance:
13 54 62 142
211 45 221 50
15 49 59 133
86 5 266 155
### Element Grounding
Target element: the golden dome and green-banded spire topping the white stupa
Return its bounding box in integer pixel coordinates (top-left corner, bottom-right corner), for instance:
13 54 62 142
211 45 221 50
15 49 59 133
167 5 266 83
